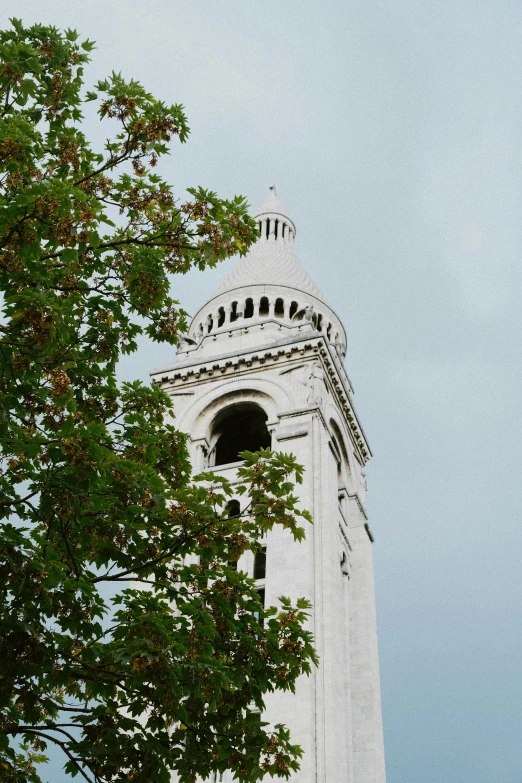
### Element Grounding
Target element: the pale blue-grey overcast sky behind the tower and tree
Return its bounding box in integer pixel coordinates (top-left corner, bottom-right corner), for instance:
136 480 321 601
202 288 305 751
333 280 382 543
1 0 522 783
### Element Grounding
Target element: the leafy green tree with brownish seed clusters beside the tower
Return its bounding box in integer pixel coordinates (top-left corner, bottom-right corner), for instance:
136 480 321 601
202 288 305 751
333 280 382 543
0 20 316 783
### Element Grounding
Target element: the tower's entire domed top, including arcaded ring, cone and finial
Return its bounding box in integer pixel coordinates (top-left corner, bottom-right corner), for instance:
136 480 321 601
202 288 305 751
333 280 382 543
179 185 346 356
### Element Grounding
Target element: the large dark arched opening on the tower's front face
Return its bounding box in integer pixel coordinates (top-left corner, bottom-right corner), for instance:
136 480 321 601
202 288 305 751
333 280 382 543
214 403 272 465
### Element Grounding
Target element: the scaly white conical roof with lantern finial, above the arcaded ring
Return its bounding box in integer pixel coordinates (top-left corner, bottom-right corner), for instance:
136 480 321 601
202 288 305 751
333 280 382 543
209 185 326 303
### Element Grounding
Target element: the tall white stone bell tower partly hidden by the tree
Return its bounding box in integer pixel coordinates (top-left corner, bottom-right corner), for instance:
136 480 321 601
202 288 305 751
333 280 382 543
152 187 385 783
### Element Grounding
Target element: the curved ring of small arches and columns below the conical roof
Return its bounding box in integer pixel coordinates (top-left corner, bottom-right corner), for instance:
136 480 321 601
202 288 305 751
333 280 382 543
194 295 343 353
